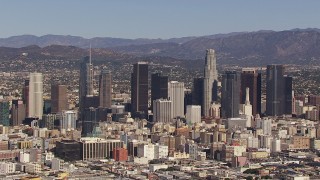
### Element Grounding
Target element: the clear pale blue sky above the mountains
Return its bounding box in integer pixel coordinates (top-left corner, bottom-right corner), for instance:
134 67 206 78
0 0 320 38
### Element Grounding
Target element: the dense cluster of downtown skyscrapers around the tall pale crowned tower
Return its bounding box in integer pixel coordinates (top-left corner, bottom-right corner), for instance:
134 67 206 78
131 49 292 126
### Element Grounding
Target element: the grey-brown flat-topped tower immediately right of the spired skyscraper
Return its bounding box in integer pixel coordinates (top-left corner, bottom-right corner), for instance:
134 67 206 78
99 69 112 108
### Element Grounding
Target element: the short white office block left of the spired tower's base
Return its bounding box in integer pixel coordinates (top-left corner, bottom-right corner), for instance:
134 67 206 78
60 111 78 130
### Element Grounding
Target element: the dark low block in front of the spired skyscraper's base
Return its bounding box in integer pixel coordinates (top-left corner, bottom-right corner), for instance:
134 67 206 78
81 107 98 136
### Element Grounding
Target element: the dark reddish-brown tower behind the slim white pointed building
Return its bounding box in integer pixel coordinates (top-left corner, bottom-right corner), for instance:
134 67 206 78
240 68 261 116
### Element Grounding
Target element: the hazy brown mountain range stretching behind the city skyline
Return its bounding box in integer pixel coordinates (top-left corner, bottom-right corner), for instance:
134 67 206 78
0 29 320 66
